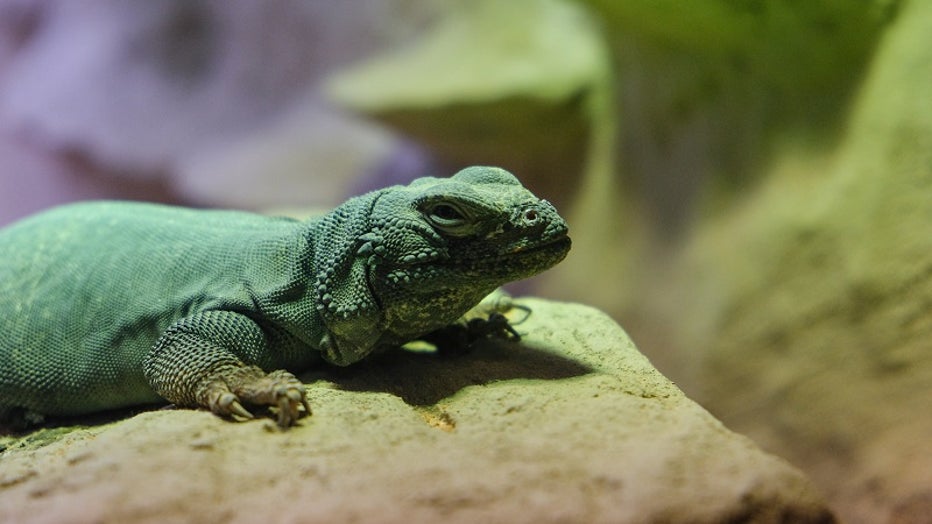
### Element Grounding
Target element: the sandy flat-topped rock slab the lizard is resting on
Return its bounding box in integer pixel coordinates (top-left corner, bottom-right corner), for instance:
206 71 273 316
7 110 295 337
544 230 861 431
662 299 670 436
0 299 833 522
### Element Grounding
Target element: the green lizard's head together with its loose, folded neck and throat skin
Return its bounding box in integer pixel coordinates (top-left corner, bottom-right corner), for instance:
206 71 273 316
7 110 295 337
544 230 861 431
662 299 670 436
315 167 570 365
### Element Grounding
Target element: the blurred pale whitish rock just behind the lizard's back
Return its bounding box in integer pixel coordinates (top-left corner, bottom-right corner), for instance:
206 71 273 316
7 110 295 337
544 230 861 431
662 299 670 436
173 101 399 209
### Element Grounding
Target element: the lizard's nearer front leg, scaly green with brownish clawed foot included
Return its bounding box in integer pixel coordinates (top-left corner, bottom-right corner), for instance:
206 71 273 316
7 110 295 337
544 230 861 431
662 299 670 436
143 311 311 427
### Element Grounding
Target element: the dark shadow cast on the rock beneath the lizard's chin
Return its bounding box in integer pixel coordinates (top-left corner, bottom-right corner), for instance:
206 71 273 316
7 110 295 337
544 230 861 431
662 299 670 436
302 341 593 406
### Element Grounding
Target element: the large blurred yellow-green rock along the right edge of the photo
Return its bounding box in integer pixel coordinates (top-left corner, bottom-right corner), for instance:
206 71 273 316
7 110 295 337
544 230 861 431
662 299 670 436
639 2 932 523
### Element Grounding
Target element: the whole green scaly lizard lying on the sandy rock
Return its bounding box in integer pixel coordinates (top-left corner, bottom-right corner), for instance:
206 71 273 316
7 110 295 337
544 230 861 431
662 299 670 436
0 166 571 428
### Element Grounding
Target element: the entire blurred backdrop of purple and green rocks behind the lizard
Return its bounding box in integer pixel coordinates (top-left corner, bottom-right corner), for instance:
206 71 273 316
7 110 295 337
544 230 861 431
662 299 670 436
0 0 932 522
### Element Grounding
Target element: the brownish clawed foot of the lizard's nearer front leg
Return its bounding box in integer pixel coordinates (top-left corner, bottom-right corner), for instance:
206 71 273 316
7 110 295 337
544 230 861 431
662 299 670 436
198 366 311 428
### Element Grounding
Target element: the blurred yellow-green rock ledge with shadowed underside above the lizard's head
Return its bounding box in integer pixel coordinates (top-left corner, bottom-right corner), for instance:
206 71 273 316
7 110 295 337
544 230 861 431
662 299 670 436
325 0 614 213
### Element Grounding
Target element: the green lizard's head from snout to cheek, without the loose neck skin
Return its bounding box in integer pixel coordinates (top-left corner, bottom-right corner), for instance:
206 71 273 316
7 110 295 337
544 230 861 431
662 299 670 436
371 167 570 291
